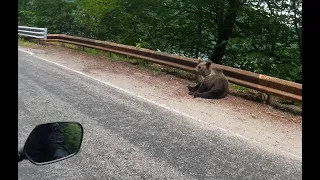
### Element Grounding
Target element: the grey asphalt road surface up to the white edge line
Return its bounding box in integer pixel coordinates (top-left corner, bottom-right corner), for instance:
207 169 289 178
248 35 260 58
18 51 302 180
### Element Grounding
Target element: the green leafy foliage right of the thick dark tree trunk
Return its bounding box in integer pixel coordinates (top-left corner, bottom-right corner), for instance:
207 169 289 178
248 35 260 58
224 0 302 82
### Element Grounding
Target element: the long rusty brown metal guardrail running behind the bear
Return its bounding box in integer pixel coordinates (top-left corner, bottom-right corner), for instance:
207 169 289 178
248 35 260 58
47 34 302 102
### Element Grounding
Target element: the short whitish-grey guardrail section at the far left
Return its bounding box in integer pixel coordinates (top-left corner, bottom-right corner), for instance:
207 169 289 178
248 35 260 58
18 26 48 40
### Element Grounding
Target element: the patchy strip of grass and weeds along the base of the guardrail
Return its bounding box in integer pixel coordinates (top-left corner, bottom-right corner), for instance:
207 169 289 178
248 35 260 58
19 40 302 114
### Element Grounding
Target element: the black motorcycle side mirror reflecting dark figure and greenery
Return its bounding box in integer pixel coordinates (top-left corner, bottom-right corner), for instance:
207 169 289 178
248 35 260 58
23 122 83 165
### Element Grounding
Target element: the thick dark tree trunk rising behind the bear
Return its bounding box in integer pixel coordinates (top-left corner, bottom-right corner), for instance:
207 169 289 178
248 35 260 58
210 0 240 64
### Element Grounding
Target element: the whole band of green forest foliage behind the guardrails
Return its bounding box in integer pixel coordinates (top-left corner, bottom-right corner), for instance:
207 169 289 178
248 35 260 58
18 0 302 83
